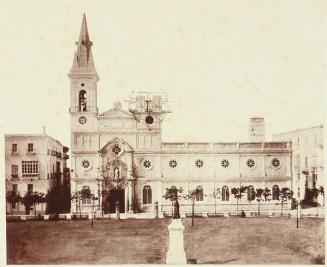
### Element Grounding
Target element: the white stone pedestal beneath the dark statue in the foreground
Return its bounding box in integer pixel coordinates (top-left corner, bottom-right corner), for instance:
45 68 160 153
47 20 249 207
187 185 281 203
166 219 186 264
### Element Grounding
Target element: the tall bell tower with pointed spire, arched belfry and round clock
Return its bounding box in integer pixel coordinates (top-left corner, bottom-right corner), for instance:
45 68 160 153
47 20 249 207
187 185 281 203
68 14 99 132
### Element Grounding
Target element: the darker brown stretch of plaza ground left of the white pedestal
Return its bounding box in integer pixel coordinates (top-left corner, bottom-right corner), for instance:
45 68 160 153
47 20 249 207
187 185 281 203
7 219 169 264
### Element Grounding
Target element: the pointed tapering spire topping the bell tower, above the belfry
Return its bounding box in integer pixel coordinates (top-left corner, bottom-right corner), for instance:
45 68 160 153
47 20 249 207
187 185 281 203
70 13 98 79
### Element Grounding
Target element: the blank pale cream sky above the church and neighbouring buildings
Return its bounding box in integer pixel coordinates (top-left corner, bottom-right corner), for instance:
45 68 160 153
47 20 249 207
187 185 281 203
0 0 326 146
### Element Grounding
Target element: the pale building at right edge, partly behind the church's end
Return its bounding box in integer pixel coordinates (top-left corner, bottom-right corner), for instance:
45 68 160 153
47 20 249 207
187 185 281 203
273 125 324 204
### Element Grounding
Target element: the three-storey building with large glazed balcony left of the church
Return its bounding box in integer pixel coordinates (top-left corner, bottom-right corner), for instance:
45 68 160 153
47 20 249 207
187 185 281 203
5 132 69 214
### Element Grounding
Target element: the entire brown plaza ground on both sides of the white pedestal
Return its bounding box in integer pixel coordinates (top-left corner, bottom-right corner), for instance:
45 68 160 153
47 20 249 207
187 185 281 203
7 217 324 264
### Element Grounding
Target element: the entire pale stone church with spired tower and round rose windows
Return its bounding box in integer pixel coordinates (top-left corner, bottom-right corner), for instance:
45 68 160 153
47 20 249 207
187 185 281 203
68 15 292 216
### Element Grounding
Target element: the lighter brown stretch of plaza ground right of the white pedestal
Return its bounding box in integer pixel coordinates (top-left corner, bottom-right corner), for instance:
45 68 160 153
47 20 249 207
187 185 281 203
183 217 325 264
